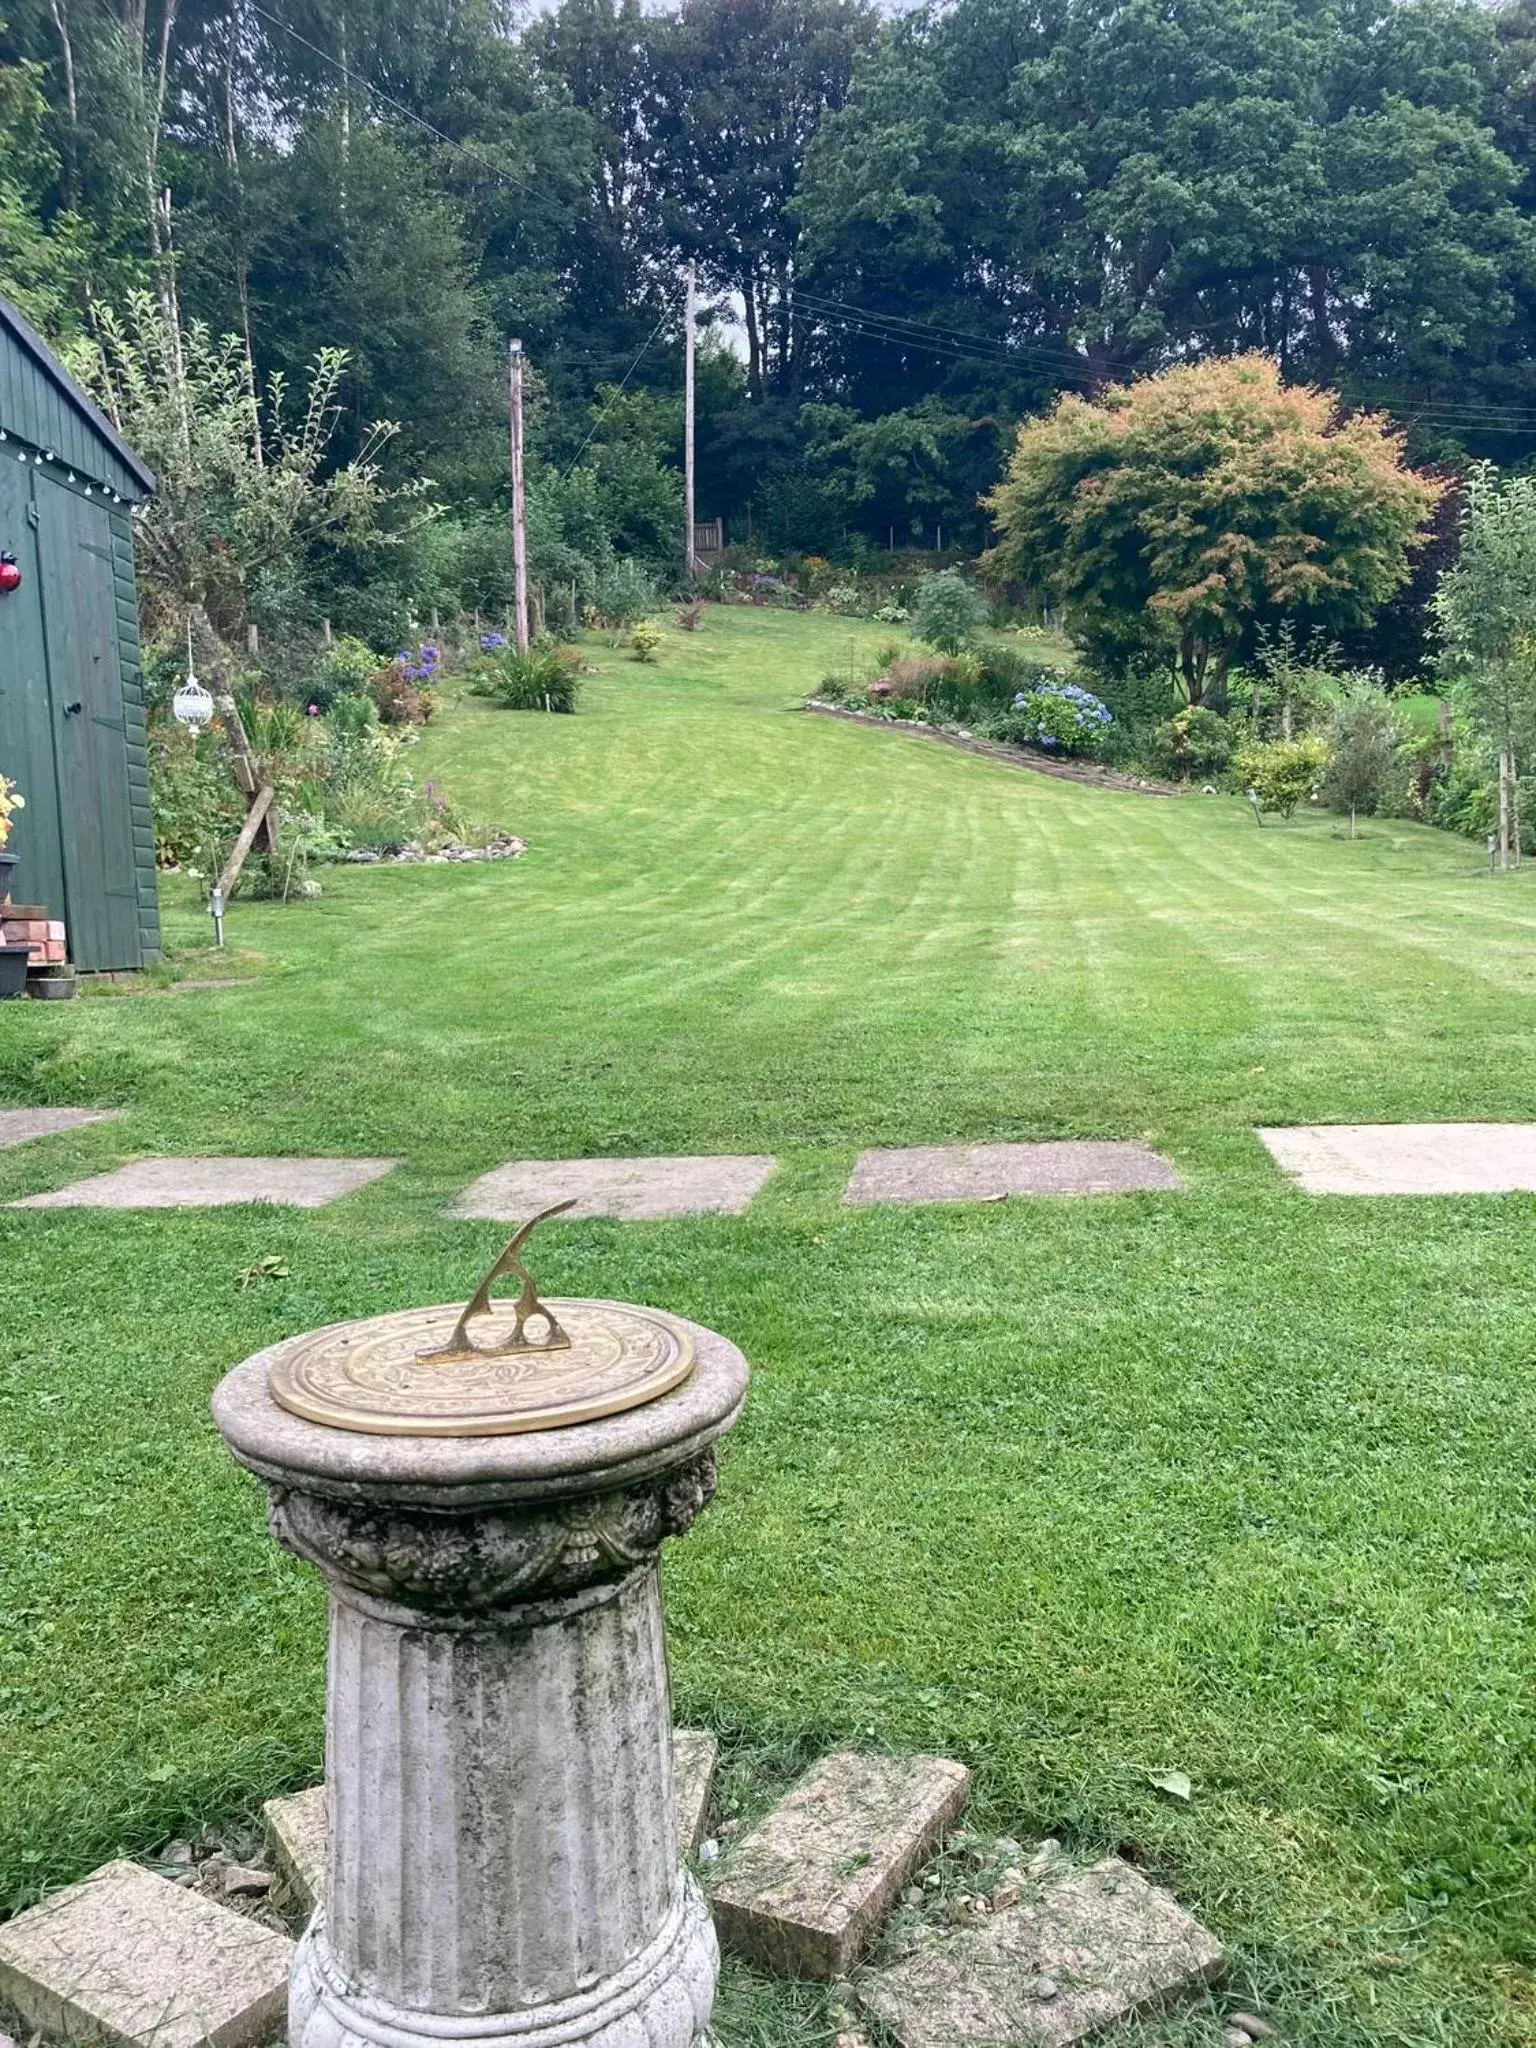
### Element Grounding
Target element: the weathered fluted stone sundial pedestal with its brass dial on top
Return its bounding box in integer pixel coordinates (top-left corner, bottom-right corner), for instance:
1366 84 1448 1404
213 1231 748 2048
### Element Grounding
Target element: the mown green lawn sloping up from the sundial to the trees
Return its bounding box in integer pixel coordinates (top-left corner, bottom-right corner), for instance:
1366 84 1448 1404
0 610 1536 2048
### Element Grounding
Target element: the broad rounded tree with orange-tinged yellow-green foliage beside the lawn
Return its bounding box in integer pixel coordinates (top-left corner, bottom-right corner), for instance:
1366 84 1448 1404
987 354 1440 705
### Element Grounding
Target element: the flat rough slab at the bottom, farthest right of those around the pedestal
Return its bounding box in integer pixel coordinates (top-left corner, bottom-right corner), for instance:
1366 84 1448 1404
856 1855 1225 2048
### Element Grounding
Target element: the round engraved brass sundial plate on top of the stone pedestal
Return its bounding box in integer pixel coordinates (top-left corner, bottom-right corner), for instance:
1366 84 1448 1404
268 1300 694 1436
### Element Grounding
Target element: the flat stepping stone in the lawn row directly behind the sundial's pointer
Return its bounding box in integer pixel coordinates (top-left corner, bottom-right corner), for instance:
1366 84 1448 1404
453 1153 776 1223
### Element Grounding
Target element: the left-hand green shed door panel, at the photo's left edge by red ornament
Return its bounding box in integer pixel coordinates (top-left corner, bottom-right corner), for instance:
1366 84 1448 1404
0 464 66 918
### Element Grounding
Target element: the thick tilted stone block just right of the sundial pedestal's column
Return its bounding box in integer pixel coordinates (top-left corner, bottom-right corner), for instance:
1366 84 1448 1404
711 1751 971 1978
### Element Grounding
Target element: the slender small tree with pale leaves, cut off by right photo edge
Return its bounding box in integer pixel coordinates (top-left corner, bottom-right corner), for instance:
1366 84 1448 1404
1434 463 1536 868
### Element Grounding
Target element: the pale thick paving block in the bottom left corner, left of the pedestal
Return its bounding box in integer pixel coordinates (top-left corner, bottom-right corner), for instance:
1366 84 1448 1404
0 1864 293 2048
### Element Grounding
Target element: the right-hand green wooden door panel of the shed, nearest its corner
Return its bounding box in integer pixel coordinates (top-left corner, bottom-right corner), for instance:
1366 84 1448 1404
33 473 139 969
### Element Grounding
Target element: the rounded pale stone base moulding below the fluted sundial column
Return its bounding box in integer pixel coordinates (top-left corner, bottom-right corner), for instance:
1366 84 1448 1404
289 1878 719 2048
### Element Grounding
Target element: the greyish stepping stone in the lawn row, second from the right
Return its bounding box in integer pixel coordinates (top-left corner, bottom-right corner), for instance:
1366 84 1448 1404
842 1139 1184 1208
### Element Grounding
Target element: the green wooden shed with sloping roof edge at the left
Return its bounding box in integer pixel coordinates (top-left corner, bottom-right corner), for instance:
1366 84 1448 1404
0 297 160 973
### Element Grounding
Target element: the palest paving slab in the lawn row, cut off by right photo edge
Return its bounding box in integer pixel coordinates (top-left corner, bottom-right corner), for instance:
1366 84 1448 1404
1260 1124 1536 1194
